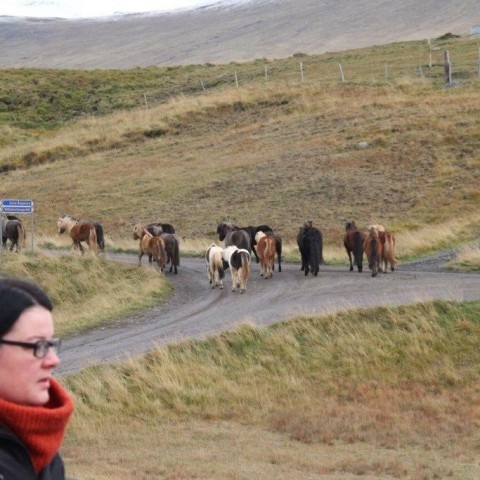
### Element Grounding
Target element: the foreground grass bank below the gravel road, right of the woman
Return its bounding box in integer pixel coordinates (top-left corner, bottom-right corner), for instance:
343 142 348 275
64 302 480 480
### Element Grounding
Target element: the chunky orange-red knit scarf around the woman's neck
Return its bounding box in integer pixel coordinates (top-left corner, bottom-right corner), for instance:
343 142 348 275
0 379 73 474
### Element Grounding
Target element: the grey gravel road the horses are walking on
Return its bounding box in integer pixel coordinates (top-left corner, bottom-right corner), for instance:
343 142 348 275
57 255 480 375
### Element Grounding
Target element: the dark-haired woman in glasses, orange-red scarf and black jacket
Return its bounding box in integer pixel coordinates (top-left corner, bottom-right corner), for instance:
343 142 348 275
0 279 73 480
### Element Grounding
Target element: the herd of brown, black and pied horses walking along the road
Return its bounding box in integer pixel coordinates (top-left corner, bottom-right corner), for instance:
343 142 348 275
1 215 397 293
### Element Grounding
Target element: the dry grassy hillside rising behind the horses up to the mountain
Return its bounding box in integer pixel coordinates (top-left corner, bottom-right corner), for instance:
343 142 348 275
0 39 480 255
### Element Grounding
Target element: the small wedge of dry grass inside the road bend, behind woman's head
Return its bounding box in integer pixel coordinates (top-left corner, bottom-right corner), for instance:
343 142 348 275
0 253 171 337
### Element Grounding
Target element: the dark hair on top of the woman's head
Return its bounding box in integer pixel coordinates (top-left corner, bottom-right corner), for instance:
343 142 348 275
0 278 53 338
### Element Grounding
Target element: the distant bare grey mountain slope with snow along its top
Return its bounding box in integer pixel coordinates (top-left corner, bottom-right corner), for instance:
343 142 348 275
0 0 480 69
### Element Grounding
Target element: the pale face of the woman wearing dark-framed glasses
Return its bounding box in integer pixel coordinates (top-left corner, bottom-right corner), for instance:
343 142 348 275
0 305 60 406
